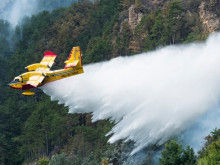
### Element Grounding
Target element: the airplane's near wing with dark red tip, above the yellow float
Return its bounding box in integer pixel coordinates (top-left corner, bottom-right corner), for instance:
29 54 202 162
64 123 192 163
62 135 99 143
22 74 45 90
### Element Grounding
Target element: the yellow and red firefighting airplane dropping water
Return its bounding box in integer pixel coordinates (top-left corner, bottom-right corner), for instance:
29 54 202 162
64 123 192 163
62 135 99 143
9 46 84 96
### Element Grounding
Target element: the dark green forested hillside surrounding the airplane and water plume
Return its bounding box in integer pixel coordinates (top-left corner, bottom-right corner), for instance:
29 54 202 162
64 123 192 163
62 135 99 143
0 0 220 165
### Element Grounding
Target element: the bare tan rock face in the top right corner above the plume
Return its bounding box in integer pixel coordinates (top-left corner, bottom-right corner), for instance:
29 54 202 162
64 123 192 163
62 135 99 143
199 1 220 33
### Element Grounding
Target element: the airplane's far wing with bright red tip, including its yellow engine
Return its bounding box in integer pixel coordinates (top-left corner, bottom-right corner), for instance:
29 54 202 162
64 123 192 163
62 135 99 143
37 51 57 71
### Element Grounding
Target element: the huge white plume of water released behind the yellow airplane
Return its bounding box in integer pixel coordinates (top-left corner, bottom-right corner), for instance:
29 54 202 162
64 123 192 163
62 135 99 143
42 34 220 154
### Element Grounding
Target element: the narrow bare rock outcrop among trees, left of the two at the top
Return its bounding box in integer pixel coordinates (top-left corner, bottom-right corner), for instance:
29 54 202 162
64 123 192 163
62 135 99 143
128 5 143 32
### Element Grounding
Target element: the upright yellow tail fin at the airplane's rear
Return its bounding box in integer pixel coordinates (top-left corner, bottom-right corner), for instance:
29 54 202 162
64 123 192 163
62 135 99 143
64 46 82 69
